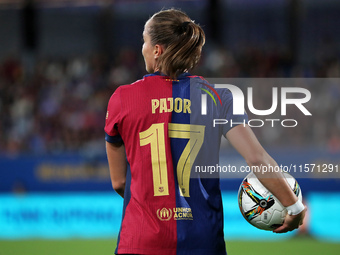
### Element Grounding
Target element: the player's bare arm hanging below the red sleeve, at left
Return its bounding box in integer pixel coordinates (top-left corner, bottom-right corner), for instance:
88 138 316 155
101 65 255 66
106 142 127 198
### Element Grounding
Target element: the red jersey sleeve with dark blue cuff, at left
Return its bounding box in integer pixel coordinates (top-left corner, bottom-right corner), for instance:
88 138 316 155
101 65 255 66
104 87 123 143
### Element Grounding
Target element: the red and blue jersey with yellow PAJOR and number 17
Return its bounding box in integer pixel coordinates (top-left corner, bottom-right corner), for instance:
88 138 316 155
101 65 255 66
105 72 246 255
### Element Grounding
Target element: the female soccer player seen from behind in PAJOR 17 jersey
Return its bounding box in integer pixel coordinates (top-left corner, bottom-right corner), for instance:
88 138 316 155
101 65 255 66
105 9 305 255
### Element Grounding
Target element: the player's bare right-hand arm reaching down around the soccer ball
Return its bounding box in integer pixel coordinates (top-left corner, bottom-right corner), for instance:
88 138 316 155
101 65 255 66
226 125 306 233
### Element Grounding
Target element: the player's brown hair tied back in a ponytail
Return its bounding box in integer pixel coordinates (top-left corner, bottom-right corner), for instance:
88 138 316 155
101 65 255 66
147 9 205 78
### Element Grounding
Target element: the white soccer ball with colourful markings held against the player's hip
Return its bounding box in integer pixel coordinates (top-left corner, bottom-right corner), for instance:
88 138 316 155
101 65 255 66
238 172 302 230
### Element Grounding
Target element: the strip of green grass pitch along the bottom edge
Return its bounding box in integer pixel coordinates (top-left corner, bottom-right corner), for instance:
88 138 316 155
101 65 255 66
0 238 340 255
